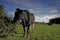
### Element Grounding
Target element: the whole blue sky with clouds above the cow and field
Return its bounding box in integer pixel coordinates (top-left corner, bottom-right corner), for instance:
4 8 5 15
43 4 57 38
0 0 60 23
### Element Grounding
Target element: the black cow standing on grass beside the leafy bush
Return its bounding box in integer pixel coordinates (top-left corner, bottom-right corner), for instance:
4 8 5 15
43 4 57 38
13 8 35 37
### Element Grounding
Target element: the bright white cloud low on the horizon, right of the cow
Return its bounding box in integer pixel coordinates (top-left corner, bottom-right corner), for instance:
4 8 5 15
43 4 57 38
35 14 60 23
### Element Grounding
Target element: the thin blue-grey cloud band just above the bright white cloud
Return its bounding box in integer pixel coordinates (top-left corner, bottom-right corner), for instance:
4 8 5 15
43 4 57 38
28 7 59 15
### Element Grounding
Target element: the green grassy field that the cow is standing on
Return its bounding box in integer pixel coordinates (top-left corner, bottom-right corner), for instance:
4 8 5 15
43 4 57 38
0 23 60 40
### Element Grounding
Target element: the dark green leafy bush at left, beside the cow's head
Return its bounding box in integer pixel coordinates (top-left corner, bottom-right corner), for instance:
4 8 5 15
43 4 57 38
0 5 15 37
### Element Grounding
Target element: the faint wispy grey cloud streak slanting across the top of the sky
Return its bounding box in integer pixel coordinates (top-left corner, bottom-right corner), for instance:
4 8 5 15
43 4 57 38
6 0 44 8
